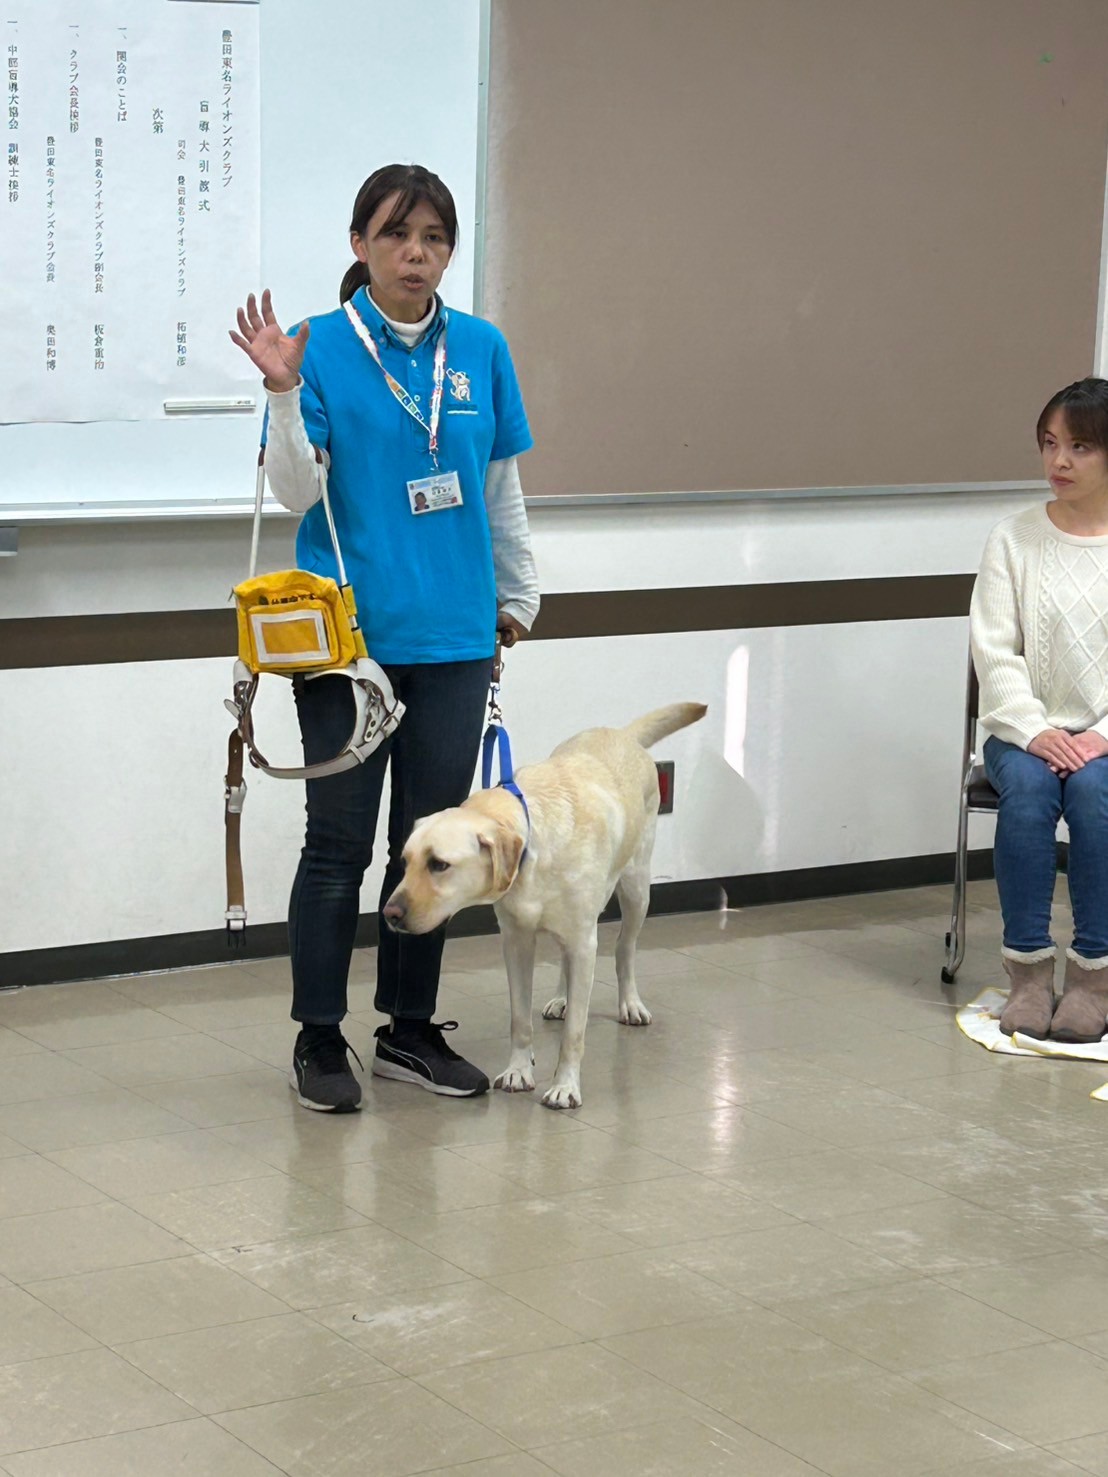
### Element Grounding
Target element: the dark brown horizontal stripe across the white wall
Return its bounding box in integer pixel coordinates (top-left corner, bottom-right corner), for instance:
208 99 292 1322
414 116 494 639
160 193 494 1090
0 575 974 671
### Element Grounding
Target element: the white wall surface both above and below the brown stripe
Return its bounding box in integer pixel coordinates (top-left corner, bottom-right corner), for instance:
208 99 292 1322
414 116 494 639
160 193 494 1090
0 495 1027 953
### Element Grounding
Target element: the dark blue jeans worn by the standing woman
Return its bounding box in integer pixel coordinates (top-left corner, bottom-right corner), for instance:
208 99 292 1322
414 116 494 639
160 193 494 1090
288 659 492 1025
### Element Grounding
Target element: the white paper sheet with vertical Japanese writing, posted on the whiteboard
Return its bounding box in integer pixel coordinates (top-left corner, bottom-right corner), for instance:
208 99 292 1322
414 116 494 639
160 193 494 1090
0 0 260 422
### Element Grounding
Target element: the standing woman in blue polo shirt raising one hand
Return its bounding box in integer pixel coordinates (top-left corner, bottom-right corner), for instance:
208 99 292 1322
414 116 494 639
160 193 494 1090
230 164 539 1112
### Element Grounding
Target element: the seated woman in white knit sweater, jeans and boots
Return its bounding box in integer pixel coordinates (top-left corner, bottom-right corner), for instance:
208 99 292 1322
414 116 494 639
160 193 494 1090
969 380 1108 1041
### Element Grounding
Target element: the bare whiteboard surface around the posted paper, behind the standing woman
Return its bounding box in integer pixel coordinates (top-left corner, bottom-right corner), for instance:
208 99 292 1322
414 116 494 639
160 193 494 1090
0 0 486 524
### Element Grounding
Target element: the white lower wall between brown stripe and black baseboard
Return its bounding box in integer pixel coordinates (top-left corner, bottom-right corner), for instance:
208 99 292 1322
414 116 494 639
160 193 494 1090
0 620 986 951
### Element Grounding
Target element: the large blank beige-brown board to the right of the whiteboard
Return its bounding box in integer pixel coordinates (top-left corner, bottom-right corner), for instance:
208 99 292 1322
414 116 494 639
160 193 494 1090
486 0 1108 493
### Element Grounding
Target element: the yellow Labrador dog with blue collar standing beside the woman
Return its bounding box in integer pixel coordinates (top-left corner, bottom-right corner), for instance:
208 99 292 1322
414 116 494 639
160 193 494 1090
384 703 708 1108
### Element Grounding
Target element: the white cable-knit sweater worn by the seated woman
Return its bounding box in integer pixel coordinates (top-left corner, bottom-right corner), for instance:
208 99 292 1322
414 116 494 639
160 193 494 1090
969 504 1108 749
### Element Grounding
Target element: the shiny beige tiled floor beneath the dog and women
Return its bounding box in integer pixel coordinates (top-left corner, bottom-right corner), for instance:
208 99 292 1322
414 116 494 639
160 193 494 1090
0 885 1108 1477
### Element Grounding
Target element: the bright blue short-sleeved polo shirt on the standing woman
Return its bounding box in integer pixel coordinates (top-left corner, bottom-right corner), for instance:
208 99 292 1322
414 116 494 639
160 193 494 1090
263 288 532 666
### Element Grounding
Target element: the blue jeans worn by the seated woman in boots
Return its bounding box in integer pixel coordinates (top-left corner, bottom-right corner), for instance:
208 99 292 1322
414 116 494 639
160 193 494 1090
984 737 1108 959
